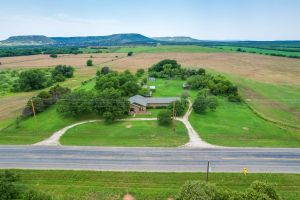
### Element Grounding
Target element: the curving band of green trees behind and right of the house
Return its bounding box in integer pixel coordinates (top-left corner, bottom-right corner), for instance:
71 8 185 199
148 59 242 113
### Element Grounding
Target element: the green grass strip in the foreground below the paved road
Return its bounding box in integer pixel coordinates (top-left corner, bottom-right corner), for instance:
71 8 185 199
6 170 300 200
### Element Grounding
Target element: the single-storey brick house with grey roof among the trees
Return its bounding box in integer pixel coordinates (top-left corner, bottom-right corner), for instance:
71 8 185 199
129 95 180 114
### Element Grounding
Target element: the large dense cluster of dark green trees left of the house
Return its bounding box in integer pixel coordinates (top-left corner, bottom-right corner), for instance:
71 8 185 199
57 67 140 121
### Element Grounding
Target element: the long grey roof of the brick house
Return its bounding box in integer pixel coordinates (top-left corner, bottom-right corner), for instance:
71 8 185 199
129 95 179 106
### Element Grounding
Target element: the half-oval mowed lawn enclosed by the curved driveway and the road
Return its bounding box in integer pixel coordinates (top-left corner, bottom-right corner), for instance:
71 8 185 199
60 120 189 147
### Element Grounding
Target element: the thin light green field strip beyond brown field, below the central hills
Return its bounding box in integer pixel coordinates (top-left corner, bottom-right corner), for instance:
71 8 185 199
115 45 232 53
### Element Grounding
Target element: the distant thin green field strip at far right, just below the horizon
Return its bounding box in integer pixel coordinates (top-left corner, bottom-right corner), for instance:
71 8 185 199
217 46 300 57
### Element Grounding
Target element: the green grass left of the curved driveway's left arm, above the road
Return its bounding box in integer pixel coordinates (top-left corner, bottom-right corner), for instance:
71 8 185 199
0 106 97 145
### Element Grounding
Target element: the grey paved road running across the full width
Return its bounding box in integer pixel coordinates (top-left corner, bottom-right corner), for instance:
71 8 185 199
0 146 300 173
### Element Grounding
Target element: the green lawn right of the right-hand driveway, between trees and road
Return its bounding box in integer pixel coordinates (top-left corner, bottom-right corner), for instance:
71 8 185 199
190 99 300 147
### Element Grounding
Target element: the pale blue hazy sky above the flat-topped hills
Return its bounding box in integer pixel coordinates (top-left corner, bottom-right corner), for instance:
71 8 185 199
0 0 300 40
